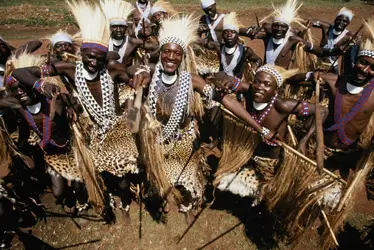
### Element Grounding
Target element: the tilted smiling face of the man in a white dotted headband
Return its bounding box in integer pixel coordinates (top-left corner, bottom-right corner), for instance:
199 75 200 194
251 72 277 103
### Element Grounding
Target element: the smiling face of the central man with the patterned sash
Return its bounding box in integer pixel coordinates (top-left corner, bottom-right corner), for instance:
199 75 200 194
161 43 184 75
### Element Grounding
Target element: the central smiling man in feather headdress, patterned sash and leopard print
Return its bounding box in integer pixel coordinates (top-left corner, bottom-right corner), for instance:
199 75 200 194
129 16 272 224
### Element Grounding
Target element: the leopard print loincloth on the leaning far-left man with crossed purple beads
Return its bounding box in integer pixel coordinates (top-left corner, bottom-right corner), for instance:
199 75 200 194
44 150 82 181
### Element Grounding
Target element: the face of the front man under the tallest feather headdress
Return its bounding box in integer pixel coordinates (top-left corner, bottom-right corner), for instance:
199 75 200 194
81 48 106 74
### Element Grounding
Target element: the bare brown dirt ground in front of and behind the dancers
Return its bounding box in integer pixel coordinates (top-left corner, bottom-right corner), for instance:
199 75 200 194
0 4 374 250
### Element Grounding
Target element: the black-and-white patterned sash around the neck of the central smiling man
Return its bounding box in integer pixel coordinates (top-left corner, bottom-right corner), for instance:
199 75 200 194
148 63 192 142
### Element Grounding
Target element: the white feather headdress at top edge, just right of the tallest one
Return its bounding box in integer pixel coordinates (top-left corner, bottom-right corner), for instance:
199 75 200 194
100 0 135 25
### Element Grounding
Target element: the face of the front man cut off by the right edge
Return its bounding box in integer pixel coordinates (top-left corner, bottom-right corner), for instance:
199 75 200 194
352 56 374 84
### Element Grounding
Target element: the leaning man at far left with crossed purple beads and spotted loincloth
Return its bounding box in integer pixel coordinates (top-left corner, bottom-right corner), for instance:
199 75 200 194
5 53 88 211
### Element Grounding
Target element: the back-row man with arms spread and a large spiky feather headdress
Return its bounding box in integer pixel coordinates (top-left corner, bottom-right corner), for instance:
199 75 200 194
247 0 319 69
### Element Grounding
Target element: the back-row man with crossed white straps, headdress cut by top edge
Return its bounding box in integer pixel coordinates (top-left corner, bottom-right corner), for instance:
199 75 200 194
198 0 225 42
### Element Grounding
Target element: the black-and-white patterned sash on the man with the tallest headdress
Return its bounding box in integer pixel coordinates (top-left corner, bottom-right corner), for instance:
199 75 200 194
75 61 116 141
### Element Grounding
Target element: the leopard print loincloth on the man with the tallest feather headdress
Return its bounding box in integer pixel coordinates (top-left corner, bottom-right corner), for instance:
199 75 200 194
92 116 139 177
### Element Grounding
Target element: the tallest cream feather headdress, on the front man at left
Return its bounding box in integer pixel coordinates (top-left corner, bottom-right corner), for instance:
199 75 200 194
66 0 110 52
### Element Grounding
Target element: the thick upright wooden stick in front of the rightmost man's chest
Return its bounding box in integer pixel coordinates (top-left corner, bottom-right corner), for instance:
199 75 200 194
315 79 325 174
